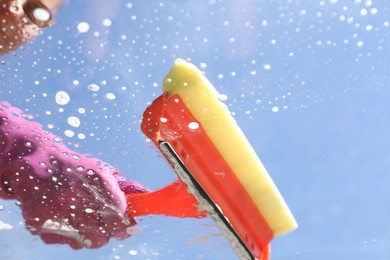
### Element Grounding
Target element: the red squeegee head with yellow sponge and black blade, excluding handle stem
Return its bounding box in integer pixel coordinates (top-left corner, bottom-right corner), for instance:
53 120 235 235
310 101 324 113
141 59 297 260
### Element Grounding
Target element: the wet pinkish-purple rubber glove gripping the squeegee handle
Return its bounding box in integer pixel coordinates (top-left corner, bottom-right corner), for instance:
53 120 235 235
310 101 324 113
0 102 147 249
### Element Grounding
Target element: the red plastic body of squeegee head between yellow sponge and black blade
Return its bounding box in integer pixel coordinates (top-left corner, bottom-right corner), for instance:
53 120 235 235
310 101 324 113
141 93 273 260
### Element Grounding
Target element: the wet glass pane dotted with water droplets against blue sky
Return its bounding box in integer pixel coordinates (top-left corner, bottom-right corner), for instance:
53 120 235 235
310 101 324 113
0 0 390 259
